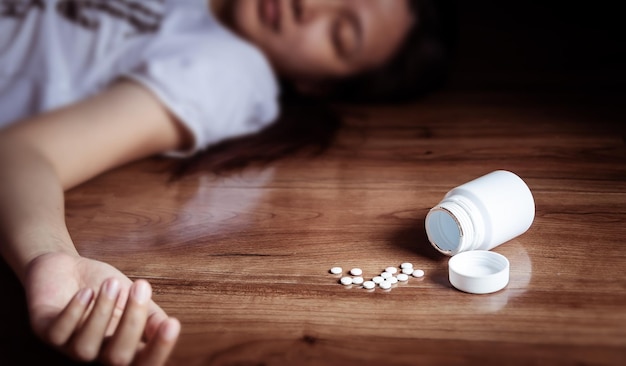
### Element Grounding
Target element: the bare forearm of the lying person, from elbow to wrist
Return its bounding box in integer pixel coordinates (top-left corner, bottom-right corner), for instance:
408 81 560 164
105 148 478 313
0 137 77 282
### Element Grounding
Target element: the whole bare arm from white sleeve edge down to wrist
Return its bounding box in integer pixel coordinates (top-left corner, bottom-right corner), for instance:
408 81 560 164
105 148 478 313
0 82 188 280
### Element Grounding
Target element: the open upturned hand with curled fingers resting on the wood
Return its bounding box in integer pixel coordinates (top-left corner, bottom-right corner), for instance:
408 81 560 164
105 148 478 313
24 253 180 365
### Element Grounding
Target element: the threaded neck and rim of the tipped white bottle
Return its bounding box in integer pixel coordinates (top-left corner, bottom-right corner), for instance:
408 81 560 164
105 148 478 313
426 194 485 255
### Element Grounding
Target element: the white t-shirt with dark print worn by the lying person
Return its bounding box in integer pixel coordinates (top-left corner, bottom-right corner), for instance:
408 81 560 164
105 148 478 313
0 0 278 153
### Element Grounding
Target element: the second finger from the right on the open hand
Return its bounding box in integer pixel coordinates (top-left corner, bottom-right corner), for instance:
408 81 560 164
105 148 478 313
102 280 152 365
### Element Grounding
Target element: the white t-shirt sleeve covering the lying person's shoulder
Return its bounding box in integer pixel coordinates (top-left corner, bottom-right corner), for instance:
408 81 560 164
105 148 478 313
125 5 279 152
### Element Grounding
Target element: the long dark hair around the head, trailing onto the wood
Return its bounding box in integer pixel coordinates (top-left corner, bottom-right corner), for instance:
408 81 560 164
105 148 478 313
175 0 456 177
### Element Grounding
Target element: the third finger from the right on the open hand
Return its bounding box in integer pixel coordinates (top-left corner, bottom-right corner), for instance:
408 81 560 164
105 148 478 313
69 278 120 361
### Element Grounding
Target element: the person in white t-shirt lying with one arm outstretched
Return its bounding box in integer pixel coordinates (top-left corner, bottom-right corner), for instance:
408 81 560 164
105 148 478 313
0 0 444 365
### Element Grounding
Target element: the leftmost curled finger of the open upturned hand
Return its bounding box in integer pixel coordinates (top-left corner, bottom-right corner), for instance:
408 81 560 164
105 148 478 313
46 288 93 347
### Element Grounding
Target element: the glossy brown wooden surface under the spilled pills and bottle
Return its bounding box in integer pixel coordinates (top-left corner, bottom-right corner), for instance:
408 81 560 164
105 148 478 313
0 92 626 365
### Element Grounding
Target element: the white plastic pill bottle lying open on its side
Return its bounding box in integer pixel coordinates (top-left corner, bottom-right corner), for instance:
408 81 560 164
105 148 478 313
425 170 535 256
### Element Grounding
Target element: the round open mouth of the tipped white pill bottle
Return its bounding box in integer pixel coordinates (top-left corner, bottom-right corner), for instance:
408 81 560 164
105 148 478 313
426 209 462 255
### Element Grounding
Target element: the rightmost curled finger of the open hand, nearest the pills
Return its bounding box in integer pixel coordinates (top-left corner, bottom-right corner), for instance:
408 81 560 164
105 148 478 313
133 318 180 366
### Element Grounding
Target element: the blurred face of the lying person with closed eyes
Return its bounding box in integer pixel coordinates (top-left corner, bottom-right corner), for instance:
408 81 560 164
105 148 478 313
224 0 414 82
